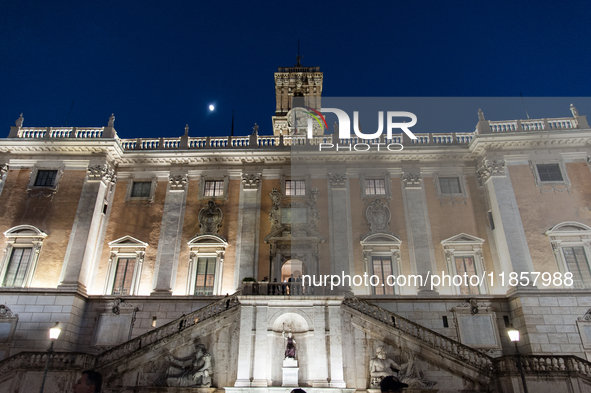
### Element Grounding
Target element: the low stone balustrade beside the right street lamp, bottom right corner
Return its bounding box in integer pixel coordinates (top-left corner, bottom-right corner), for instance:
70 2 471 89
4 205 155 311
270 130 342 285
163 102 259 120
494 355 591 379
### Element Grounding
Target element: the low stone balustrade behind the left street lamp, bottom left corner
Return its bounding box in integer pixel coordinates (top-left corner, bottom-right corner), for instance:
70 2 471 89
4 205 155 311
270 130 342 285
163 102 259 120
0 352 95 375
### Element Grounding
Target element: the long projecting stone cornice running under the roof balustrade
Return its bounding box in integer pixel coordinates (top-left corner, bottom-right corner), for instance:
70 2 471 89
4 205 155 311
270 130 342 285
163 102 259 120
0 129 591 169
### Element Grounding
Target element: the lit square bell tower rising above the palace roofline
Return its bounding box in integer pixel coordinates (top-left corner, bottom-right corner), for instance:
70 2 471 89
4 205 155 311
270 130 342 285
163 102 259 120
273 53 322 135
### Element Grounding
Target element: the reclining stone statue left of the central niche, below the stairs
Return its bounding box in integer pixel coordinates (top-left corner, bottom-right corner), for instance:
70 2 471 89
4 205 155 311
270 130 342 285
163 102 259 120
156 343 213 388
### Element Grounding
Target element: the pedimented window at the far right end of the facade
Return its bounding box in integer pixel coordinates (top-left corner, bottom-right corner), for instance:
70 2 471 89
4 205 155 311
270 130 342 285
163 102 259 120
546 221 591 288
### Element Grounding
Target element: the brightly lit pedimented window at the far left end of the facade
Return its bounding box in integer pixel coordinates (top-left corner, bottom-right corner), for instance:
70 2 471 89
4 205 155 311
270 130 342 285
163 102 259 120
0 225 47 287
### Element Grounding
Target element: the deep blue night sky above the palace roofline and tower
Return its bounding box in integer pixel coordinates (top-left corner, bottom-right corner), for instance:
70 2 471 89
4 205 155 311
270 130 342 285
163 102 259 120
0 0 591 138
